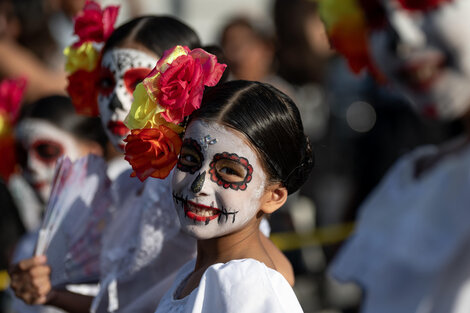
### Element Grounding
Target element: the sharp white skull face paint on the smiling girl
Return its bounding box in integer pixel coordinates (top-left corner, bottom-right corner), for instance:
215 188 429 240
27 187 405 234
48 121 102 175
173 120 266 239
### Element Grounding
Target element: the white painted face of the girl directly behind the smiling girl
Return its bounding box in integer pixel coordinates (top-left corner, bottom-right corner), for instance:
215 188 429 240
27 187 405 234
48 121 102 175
98 48 158 151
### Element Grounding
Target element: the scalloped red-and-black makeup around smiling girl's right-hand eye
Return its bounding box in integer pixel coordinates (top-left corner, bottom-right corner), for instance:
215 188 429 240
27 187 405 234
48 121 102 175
209 152 253 191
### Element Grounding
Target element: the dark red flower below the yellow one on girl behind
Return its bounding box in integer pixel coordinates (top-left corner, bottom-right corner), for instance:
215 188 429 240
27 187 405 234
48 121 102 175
67 66 100 116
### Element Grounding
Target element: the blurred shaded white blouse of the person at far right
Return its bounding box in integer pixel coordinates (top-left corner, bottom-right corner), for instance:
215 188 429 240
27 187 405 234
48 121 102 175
331 140 470 313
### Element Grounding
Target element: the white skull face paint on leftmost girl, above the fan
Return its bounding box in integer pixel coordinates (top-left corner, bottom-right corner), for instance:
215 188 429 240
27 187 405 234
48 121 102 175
16 118 82 202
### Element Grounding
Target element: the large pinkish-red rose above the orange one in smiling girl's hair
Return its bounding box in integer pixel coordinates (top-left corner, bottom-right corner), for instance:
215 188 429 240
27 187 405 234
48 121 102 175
157 47 227 123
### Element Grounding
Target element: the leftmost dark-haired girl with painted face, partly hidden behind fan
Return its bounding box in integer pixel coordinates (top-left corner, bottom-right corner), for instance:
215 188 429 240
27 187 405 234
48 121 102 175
10 95 107 312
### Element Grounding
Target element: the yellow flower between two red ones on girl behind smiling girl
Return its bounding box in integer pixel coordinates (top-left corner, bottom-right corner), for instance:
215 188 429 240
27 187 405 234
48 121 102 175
64 42 100 74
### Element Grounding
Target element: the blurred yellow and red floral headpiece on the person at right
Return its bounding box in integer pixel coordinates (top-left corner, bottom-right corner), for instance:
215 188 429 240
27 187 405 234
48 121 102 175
319 0 452 77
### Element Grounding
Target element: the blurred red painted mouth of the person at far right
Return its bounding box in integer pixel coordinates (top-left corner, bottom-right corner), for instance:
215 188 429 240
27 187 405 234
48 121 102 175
397 54 446 92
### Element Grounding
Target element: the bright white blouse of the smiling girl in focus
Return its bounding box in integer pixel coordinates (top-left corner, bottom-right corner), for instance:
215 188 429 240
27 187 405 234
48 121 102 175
156 259 303 313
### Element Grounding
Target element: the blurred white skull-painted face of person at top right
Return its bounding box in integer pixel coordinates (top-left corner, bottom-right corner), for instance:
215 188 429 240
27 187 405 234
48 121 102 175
370 0 470 119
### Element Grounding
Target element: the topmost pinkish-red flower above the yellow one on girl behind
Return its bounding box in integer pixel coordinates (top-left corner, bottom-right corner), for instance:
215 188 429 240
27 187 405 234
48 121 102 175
74 1 119 46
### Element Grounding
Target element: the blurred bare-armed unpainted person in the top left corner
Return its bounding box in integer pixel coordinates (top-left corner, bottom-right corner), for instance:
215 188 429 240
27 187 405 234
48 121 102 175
0 0 78 102
